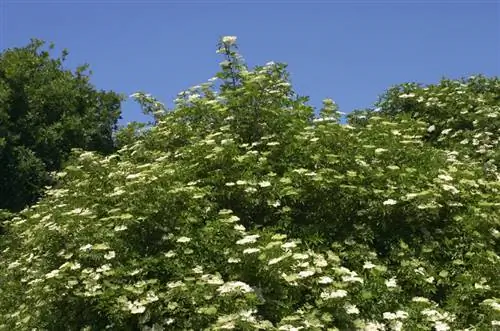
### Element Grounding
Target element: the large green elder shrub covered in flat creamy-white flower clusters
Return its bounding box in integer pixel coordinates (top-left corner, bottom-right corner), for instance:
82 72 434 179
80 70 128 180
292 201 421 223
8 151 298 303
0 37 500 330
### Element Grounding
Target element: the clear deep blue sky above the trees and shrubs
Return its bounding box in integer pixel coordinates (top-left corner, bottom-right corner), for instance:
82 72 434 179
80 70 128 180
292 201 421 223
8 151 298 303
0 0 500 123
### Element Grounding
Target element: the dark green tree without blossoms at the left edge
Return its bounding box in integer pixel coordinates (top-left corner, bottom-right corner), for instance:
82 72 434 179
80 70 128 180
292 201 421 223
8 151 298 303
0 40 122 211
